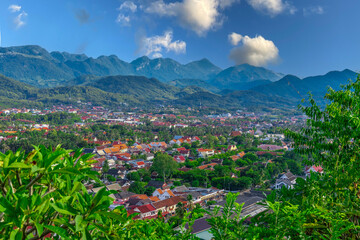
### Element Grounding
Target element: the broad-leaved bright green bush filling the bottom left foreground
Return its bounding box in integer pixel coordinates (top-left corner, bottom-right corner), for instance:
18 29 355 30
0 146 198 239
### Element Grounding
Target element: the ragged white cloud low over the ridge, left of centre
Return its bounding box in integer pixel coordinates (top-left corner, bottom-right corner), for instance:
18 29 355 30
140 31 186 58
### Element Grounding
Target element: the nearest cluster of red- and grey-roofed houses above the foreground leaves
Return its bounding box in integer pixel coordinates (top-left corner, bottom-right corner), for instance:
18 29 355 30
87 180 225 219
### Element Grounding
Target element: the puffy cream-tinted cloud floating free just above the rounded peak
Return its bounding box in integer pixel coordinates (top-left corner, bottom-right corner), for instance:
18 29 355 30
229 33 279 66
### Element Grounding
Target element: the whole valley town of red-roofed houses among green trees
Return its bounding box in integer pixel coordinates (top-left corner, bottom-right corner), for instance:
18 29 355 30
0 105 323 239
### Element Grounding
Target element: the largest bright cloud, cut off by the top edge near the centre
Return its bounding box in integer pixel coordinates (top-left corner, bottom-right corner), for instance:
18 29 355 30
145 0 238 35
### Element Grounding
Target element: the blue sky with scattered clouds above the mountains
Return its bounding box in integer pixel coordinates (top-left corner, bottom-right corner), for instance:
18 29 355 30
0 0 360 77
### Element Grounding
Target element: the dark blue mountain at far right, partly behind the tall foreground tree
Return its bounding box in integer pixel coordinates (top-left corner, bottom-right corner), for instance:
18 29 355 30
251 69 357 101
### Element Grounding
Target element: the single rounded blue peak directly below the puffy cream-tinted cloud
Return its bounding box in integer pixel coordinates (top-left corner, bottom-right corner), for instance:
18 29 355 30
209 64 283 90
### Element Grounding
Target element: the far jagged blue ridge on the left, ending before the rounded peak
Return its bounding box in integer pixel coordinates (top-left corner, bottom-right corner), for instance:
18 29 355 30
0 45 221 87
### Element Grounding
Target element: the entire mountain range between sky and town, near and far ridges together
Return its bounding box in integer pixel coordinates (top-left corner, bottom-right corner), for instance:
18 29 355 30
0 46 357 109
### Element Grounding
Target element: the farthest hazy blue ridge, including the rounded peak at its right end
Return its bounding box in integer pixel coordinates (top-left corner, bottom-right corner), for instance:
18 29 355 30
0 45 282 90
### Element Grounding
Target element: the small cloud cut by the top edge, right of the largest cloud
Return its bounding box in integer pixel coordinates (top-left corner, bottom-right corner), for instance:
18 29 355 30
248 0 296 16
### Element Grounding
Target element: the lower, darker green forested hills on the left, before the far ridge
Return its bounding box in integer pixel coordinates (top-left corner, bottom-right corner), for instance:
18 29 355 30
0 75 211 107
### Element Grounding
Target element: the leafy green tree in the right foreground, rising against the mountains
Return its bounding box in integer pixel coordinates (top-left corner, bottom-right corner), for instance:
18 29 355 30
248 78 360 239
